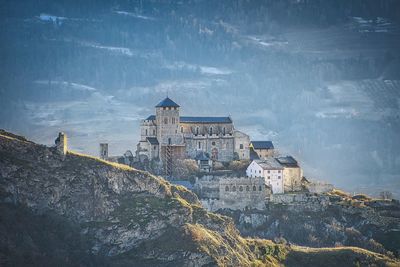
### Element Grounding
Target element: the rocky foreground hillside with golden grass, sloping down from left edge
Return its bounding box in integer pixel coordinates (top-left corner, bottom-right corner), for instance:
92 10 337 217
0 131 400 266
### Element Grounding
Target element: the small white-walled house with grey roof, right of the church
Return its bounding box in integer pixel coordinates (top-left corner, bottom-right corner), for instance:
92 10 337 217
246 158 283 194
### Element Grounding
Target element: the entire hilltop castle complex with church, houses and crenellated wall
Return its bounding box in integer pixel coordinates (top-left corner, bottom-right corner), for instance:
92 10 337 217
93 97 332 209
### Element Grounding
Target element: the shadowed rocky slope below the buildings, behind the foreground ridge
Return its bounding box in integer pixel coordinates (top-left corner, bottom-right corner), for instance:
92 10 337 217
220 195 400 256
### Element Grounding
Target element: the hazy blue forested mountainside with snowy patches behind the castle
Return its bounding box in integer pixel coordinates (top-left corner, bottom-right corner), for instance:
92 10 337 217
0 0 400 198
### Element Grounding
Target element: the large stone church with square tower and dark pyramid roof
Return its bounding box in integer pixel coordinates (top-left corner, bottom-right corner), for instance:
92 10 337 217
137 97 250 164
